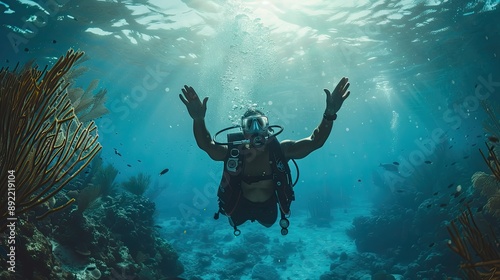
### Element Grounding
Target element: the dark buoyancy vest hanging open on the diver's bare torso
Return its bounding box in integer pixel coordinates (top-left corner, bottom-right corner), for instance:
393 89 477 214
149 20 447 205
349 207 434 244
214 133 295 235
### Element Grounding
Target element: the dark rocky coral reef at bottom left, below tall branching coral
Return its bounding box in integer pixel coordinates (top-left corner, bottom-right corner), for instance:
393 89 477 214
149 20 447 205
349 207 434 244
1 192 184 280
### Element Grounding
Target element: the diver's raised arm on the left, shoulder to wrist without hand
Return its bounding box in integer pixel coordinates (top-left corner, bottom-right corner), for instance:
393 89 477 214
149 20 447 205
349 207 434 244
193 119 227 161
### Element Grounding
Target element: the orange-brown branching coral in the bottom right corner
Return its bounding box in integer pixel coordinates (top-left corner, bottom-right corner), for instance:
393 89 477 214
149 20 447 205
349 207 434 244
447 208 500 280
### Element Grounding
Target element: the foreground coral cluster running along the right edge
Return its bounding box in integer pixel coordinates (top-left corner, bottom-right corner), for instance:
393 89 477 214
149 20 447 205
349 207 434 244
447 101 500 279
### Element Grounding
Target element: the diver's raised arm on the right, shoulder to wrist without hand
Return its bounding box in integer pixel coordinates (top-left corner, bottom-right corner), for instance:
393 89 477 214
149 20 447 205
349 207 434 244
281 118 333 159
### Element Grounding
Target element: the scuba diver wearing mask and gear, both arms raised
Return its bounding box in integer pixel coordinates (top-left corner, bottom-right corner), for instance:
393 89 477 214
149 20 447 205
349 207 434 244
179 77 350 235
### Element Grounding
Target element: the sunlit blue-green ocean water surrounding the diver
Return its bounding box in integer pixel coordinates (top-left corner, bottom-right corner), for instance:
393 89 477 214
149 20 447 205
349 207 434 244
0 0 500 279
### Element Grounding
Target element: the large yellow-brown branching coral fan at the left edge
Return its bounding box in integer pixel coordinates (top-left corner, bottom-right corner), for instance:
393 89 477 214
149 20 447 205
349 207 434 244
0 50 101 231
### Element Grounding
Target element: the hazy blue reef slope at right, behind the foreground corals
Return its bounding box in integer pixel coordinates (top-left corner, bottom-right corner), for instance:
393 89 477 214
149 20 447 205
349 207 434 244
347 135 497 279
